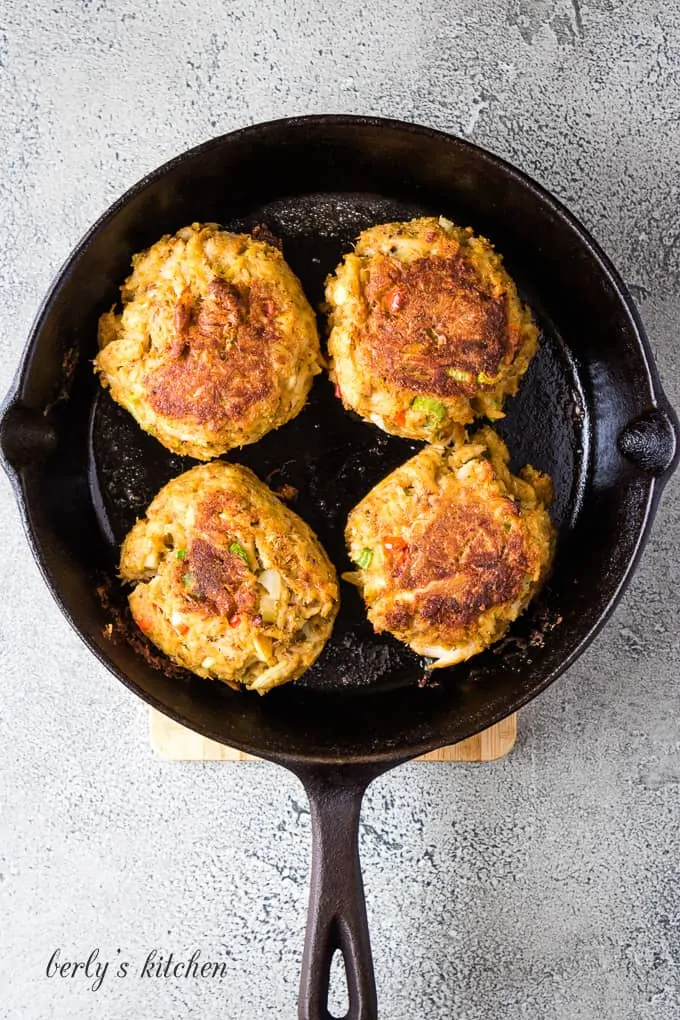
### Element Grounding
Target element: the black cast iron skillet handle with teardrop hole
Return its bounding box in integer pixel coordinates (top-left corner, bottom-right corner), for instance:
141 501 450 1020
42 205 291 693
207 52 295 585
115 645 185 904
298 768 377 1020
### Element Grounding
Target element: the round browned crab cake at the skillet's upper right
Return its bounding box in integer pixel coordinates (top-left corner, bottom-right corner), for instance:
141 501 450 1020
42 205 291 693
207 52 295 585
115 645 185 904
326 217 538 442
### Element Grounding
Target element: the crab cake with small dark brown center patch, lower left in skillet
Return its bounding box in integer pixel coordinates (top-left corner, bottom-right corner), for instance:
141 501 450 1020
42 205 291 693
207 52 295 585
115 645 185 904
120 461 338 694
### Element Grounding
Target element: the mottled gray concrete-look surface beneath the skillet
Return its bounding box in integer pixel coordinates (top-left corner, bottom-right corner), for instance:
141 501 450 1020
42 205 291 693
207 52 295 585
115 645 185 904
0 0 680 1020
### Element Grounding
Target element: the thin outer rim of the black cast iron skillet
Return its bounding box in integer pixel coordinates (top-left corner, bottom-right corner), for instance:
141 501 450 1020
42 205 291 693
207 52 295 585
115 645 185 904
0 114 675 770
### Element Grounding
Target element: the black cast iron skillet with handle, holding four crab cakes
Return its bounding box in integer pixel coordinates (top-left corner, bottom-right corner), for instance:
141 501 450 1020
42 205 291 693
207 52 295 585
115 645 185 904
0 116 677 1020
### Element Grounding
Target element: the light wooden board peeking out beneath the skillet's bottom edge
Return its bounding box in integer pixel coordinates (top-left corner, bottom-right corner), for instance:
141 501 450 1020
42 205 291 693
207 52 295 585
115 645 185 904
149 708 517 762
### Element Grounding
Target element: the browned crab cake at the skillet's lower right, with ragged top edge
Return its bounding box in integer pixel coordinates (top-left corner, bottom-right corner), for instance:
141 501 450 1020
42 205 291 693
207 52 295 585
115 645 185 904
345 427 555 667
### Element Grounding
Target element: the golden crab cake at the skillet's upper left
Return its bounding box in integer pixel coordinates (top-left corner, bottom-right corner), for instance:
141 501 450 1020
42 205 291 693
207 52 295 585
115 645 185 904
95 223 321 460
